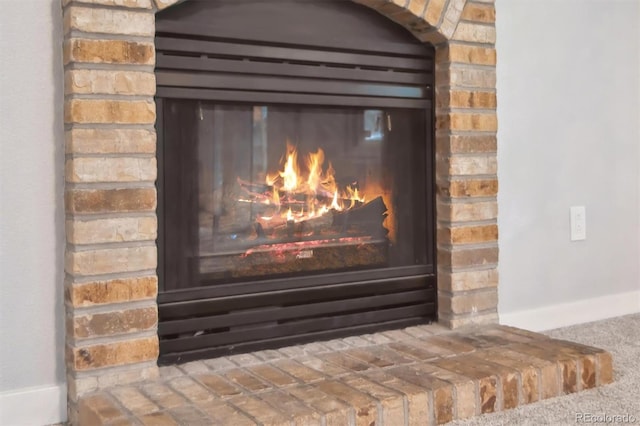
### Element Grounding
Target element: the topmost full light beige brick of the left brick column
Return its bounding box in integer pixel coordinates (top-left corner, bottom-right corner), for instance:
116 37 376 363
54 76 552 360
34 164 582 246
64 6 155 37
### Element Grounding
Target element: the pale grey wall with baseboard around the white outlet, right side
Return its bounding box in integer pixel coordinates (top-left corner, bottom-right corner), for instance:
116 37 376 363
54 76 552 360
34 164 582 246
496 0 640 329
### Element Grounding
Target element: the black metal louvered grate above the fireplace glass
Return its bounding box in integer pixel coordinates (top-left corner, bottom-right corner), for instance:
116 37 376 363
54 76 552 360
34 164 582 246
156 36 433 108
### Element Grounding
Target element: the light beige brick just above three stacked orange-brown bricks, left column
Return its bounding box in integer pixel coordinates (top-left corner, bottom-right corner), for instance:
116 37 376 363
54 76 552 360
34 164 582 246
65 246 157 276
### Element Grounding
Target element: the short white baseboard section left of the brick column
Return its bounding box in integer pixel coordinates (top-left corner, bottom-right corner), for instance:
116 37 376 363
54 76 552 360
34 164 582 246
0 383 67 426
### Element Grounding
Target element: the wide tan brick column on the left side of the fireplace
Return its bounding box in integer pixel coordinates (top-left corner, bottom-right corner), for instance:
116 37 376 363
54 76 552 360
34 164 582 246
62 0 158 414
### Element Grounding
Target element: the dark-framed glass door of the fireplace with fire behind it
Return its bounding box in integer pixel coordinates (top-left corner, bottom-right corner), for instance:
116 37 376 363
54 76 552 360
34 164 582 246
161 99 429 291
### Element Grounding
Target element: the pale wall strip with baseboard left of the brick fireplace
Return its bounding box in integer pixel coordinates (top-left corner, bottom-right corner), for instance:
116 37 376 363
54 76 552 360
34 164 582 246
0 0 66 425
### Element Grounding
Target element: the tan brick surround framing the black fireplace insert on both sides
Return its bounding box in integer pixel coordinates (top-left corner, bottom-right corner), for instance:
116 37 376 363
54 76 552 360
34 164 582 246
62 0 498 412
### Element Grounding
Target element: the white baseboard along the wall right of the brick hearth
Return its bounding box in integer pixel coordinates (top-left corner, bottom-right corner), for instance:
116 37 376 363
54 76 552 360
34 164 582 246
500 290 640 331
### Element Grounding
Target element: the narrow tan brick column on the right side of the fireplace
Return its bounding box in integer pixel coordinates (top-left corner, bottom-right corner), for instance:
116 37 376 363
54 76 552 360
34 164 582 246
436 0 498 328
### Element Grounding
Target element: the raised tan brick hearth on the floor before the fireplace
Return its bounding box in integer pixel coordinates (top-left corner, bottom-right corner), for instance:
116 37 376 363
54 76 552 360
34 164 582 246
79 326 612 426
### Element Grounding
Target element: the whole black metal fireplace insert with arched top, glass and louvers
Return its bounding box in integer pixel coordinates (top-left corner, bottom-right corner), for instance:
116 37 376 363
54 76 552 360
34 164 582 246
156 1 436 363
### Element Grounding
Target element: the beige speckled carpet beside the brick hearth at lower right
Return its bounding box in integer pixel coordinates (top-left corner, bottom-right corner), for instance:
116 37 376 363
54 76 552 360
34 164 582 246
449 314 640 426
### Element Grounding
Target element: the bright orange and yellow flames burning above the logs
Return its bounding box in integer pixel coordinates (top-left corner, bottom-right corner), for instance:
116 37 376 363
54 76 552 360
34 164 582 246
263 144 365 222
